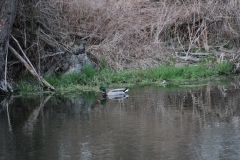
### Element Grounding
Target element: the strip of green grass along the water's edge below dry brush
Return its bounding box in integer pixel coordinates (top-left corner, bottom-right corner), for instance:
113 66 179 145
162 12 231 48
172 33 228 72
17 62 232 92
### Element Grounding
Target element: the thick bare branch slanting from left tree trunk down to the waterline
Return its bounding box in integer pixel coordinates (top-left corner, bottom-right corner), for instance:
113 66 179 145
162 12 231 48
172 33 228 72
9 45 55 90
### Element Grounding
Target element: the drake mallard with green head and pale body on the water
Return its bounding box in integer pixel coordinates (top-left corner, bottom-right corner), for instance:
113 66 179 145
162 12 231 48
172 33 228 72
99 86 129 97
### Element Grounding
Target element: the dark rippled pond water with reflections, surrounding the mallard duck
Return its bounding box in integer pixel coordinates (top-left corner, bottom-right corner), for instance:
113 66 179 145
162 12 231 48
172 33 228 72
0 82 240 160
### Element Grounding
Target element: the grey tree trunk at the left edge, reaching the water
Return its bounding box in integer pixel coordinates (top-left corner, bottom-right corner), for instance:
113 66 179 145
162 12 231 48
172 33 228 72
0 0 19 94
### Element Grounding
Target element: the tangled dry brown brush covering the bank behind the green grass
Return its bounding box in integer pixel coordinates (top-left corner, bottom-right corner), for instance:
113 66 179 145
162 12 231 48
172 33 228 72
9 0 240 73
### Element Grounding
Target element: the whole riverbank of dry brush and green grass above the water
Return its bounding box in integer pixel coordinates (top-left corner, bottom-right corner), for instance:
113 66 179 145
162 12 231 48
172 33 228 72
0 0 240 93
